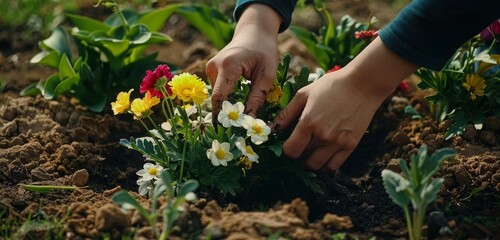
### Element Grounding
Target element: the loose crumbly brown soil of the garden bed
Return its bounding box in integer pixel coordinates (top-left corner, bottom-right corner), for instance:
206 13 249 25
0 1 500 239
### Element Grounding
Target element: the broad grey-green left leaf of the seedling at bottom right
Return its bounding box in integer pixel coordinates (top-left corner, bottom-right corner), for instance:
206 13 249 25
382 169 410 209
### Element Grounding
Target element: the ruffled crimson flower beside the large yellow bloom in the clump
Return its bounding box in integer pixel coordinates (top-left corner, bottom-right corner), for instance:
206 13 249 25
139 64 174 99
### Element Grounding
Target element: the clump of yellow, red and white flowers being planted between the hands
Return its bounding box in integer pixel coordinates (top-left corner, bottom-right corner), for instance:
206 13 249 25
111 56 321 196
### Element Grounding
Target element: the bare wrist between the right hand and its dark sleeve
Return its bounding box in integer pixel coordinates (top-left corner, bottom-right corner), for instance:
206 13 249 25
344 38 419 104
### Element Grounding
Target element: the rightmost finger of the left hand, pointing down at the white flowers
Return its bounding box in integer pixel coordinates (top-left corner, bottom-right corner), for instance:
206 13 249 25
245 69 276 117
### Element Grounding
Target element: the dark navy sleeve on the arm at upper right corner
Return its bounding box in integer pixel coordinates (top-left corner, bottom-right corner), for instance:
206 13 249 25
379 0 500 70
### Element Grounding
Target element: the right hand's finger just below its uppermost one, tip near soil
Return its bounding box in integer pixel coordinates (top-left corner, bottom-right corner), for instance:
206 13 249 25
283 121 312 158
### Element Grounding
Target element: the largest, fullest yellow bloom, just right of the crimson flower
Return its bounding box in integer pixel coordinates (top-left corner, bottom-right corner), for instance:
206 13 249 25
168 73 208 104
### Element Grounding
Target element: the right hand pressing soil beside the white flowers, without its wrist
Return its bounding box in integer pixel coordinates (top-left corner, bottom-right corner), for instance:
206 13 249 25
272 70 381 171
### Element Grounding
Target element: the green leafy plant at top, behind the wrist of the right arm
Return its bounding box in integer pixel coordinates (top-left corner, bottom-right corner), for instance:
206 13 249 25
290 1 378 69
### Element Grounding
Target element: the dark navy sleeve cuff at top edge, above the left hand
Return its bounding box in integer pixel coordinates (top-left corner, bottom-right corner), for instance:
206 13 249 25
234 0 297 32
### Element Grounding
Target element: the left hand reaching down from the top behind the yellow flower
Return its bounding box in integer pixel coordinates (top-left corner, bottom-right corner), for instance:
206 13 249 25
206 4 282 116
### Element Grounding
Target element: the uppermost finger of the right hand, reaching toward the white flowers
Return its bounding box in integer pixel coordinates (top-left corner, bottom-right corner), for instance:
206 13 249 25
270 89 307 131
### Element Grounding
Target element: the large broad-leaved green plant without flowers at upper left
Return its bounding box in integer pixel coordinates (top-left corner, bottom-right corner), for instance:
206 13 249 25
21 0 180 112
